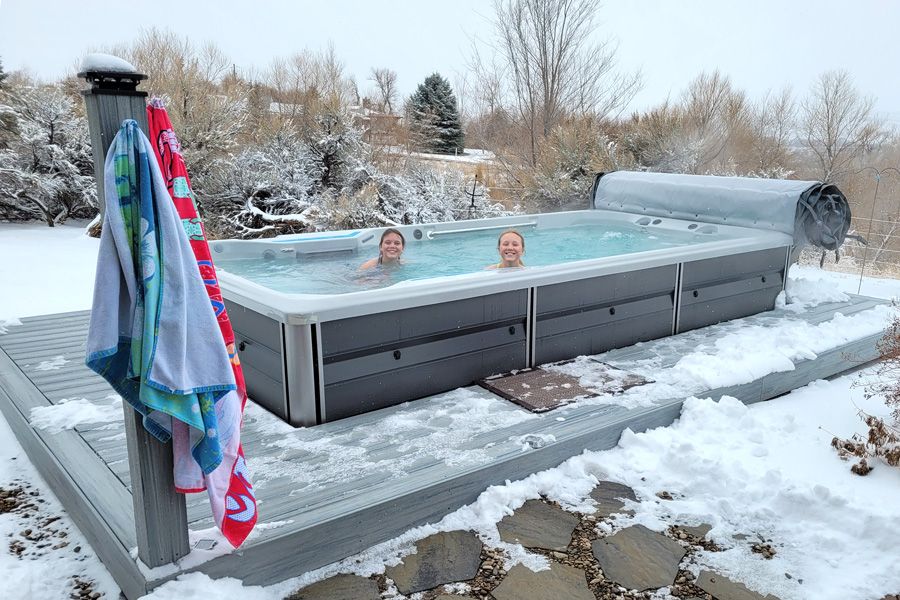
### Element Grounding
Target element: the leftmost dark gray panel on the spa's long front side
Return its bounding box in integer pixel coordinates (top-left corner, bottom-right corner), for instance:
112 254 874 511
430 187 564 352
321 290 528 421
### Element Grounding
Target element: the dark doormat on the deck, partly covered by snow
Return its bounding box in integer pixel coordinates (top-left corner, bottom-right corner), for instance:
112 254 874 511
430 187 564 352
478 361 652 412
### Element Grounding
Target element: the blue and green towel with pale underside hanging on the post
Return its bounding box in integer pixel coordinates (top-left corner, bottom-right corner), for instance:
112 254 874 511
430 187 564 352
86 120 253 541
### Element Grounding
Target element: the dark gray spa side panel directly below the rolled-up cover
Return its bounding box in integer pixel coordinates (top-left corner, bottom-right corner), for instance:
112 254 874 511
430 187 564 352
677 248 788 333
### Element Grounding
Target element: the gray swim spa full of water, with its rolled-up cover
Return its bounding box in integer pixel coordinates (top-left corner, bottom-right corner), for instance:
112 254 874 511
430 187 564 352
212 173 849 425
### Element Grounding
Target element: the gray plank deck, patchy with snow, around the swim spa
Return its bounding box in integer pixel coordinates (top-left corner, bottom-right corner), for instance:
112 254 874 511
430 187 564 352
0 296 883 598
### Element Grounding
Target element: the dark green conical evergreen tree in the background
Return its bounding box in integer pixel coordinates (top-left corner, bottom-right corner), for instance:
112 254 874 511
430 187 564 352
408 73 465 154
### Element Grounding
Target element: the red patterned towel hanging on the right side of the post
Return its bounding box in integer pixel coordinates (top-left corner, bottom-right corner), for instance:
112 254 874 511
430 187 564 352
147 98 258 547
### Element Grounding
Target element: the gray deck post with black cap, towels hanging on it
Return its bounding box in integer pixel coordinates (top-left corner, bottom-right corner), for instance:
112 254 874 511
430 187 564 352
78 59 190 567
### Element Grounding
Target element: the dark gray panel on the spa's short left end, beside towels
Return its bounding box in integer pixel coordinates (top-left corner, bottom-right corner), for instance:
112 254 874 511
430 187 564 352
225 300 289 421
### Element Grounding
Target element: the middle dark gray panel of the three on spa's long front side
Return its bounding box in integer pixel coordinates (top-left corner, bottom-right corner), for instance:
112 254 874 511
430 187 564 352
534 266 676 364
